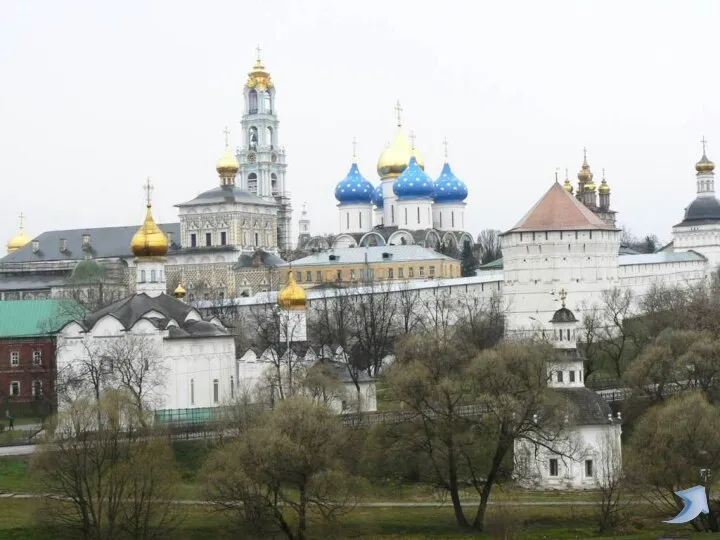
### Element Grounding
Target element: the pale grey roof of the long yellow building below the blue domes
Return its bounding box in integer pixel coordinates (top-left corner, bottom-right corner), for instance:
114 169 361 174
285 244 455 266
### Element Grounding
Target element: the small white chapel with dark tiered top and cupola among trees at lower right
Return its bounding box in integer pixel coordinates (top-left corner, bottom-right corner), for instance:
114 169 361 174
513 291 622 489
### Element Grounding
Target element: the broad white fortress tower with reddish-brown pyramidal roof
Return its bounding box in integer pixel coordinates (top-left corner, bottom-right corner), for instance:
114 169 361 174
500 181 620 332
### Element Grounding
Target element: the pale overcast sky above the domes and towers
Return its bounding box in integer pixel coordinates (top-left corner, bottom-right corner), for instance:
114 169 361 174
0 0 720 247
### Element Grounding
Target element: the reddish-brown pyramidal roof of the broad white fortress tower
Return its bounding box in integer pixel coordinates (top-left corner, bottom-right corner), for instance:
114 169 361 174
505 182 618 234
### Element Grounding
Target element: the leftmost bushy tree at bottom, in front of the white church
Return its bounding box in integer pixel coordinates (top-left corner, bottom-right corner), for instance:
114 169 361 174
32 391 178 540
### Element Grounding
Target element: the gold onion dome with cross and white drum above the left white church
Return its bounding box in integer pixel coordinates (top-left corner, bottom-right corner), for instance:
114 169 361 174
130 178 168 297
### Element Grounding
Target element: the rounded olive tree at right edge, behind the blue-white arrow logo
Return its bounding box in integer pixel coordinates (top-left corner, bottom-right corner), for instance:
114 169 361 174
625 392 720 532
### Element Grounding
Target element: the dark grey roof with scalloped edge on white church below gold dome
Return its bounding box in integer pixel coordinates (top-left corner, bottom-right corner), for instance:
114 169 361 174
84 293 228 339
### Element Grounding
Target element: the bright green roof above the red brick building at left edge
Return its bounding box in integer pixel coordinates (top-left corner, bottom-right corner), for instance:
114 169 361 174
0 299 75 338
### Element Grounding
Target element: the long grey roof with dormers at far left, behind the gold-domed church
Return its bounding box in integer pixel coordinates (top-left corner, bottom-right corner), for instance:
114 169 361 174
0 223 180 264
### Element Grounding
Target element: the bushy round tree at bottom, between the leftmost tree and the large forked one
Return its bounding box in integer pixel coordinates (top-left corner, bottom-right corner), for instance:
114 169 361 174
202 397 356 540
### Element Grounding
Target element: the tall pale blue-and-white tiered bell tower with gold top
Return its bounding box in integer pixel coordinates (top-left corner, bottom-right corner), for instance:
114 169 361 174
237 47 292 251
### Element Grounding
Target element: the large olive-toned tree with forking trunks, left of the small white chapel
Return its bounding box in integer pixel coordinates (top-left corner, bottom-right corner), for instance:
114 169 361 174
385 338 560 531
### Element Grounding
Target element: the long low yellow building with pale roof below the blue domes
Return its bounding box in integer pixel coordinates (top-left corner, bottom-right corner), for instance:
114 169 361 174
281 245 460 288
